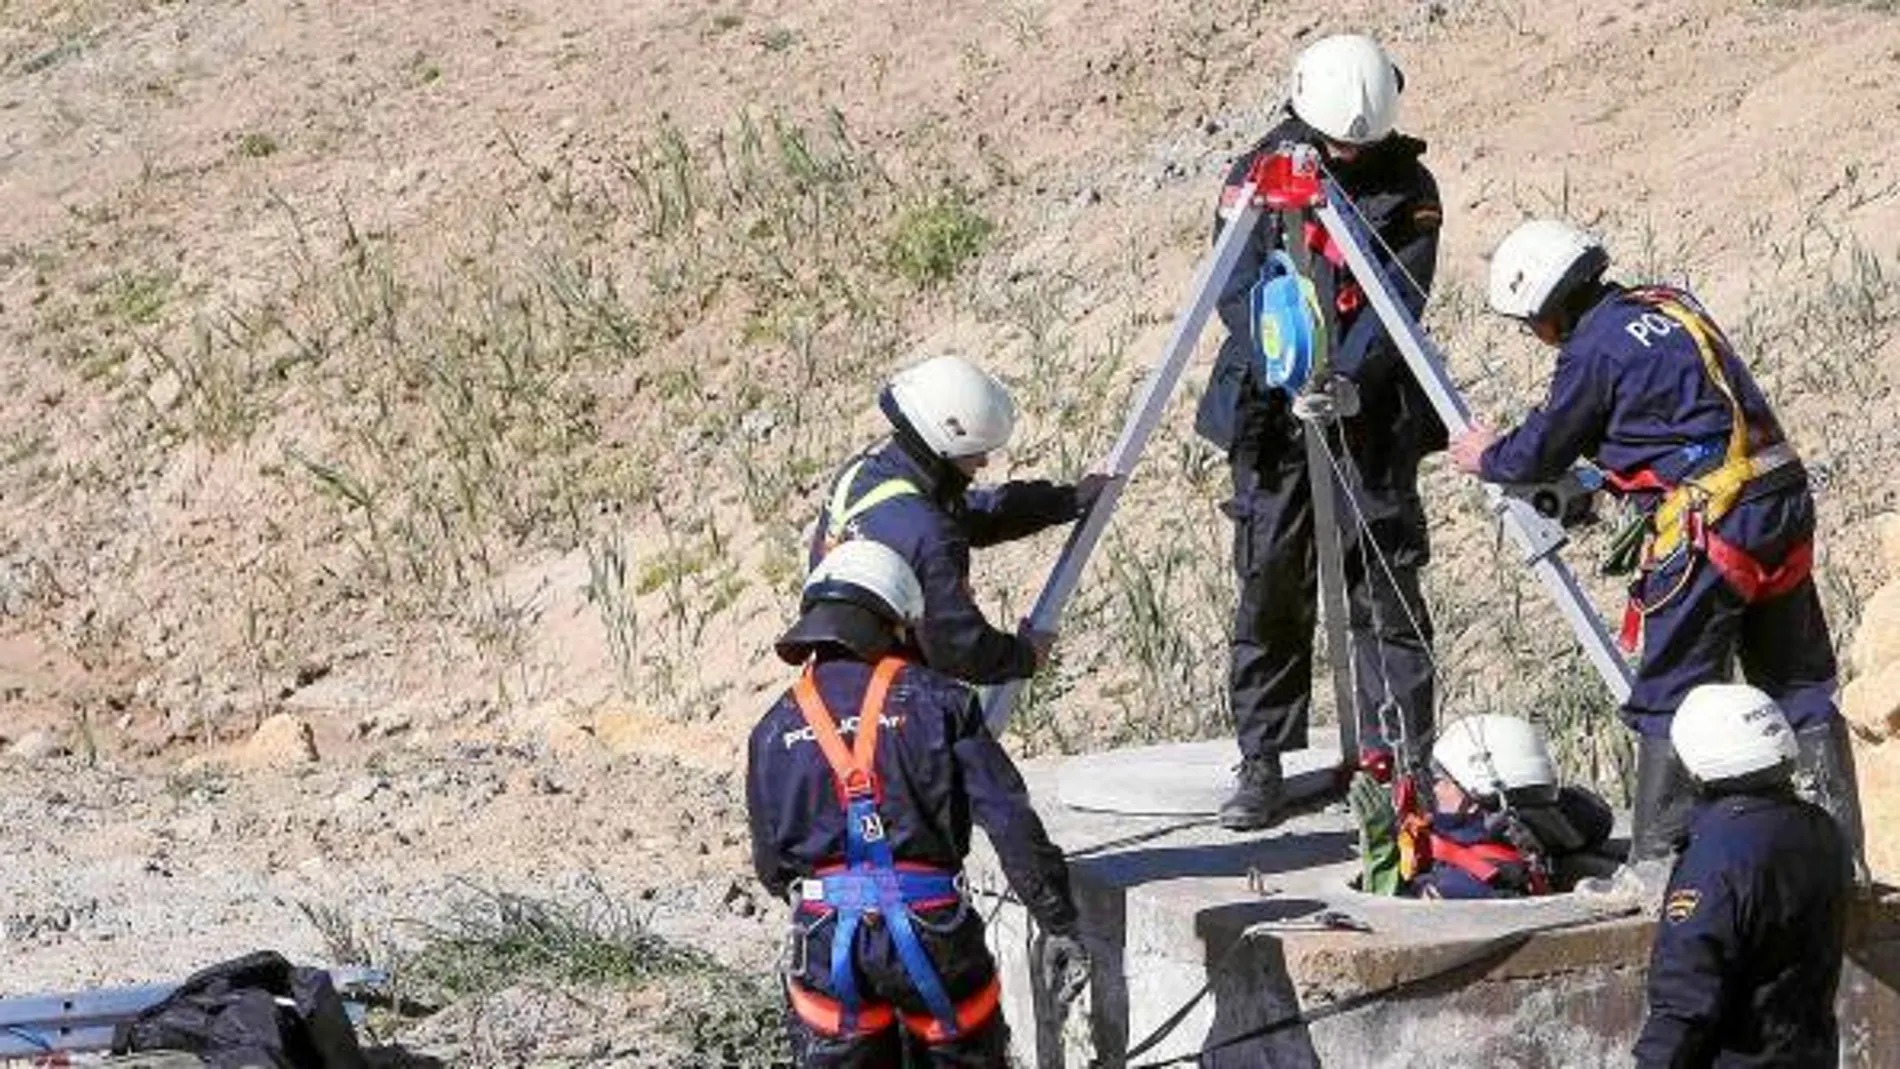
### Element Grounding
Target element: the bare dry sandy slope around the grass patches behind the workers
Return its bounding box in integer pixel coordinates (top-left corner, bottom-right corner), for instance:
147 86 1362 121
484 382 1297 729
0 0 1900 1055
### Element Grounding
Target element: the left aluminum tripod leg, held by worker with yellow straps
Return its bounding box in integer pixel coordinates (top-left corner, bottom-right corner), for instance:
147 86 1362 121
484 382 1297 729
982 182 1262 735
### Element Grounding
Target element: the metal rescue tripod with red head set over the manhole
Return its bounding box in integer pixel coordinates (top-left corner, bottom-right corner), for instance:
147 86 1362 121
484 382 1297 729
984 146 1630 744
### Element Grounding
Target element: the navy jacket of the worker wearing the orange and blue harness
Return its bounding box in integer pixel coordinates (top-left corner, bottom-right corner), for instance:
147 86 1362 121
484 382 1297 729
745 659 1075 932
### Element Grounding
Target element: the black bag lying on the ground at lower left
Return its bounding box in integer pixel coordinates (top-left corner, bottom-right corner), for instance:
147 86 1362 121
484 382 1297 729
112 951 369 1069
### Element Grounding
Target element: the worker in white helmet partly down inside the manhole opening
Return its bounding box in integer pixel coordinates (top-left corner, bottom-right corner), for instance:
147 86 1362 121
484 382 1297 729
1349 716 1617 898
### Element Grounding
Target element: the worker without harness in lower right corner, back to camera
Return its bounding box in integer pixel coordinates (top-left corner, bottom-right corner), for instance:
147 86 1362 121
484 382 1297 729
1636 684 1853 1069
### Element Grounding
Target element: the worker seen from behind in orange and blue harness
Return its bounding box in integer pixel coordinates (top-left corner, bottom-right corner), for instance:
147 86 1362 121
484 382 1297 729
747 539 1089 1067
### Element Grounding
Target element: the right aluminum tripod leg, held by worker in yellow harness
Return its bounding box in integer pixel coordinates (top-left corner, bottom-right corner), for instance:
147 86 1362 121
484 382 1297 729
1313 180 1630 703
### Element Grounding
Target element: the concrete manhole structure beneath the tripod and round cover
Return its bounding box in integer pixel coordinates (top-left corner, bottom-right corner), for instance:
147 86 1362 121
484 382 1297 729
969 748 1900 1069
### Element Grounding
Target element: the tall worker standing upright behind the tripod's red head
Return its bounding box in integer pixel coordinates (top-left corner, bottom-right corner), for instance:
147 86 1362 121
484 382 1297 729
1195 36 1444 830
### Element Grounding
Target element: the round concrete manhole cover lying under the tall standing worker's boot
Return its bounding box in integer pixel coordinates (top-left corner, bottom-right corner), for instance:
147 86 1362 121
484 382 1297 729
1055 739 1340 816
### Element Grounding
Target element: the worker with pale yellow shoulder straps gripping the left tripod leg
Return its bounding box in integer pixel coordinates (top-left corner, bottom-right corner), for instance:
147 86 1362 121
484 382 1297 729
809 357 1108 684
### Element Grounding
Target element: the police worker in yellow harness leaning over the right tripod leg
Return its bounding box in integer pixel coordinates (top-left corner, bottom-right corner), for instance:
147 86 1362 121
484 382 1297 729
1452 220 1860 877
